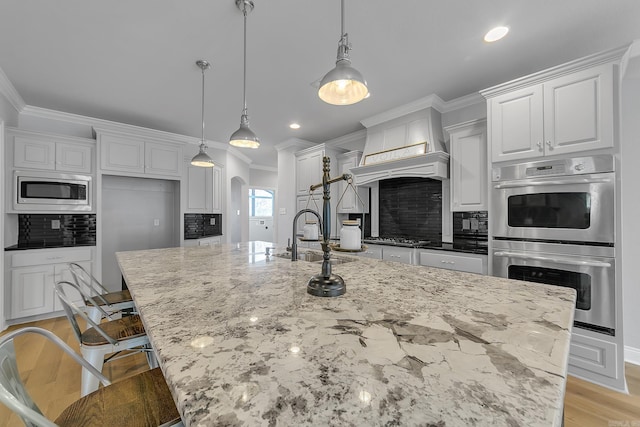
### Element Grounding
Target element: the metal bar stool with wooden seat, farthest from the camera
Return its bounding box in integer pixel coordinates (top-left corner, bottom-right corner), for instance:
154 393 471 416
69 262 135 323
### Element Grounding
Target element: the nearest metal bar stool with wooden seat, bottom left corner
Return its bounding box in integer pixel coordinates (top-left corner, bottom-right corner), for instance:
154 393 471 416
0 327 182 427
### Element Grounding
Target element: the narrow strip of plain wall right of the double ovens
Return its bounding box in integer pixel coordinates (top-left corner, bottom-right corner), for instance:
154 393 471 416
620 43 640 364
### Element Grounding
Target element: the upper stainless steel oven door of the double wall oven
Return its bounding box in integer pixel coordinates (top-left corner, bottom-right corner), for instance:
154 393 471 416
491 172 615 244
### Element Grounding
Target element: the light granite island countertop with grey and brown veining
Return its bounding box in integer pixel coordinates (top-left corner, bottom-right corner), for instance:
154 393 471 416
117 242 575 427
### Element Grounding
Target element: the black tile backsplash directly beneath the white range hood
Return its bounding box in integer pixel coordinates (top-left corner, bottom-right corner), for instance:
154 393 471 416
379 178 442 243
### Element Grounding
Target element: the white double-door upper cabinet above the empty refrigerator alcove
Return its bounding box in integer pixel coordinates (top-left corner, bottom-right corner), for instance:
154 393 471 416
98 133 182 177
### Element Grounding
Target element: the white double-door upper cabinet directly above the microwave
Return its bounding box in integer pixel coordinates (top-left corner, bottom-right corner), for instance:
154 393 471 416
8 129 94 174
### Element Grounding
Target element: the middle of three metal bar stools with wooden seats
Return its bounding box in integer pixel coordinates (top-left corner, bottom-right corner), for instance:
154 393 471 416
55 280 158 396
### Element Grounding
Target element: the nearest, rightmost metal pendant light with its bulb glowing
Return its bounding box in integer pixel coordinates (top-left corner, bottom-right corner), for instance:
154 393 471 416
318 0 369 105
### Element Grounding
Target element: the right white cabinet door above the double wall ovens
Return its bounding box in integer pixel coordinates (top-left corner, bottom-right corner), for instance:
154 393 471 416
544 64 614 155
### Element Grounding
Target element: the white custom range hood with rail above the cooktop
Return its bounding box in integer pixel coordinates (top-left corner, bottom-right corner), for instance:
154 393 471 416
351 103 449 186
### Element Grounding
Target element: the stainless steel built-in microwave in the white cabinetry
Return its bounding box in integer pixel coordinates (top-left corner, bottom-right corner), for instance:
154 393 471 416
13 171 92 212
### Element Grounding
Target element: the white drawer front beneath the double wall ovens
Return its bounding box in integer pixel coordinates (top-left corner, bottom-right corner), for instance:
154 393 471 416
569 327 617 378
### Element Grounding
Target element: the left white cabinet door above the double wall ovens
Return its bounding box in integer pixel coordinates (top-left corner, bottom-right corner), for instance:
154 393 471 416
490 85 544 162
